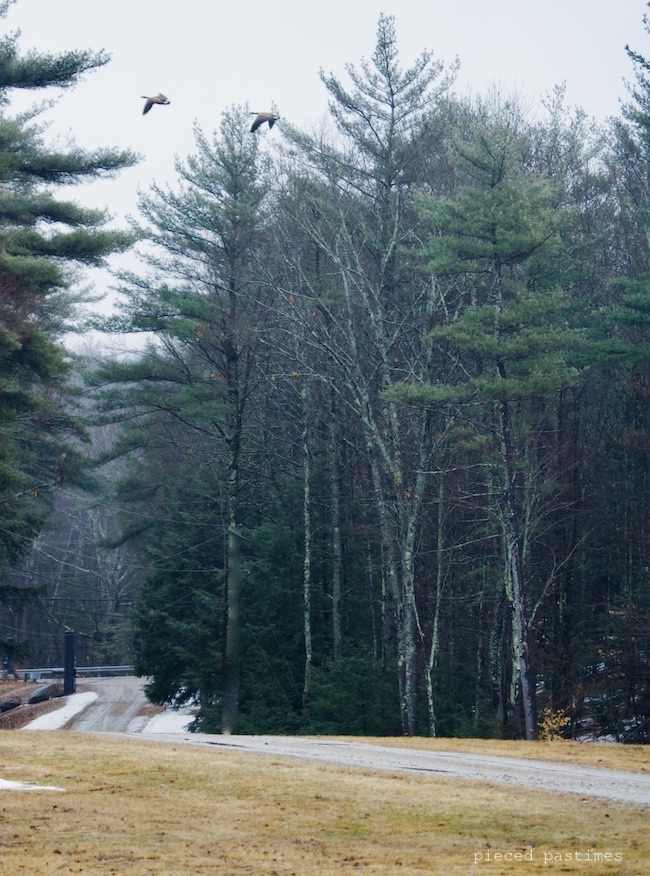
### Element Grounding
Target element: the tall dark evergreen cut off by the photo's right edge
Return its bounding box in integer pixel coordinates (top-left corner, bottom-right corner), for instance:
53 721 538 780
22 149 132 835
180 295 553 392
578 4 650 741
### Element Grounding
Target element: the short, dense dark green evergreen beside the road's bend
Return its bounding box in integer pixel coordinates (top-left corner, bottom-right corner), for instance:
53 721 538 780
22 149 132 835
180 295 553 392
127 448 224 716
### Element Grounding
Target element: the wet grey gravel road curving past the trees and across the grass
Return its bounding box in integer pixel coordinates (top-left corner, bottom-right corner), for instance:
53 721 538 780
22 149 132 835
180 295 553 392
66 677 650 808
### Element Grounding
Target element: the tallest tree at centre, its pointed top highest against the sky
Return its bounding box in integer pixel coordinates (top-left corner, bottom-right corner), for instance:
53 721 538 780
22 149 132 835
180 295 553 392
276 16 454 734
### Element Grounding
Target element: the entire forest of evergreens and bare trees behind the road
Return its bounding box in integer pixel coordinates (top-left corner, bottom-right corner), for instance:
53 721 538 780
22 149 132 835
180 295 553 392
0 3 650 743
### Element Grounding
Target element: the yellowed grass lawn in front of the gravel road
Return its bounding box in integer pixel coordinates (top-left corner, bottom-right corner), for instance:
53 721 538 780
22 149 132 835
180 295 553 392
0 730 650 876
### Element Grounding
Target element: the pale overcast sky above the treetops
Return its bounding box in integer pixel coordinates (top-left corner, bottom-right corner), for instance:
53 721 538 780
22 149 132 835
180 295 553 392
0 0 650 332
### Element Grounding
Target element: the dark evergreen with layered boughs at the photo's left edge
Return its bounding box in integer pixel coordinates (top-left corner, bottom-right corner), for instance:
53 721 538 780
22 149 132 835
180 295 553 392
0 0 135 656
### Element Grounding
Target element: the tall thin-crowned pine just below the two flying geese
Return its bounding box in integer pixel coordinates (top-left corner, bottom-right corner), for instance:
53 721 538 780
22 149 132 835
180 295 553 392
93 107 267 732
